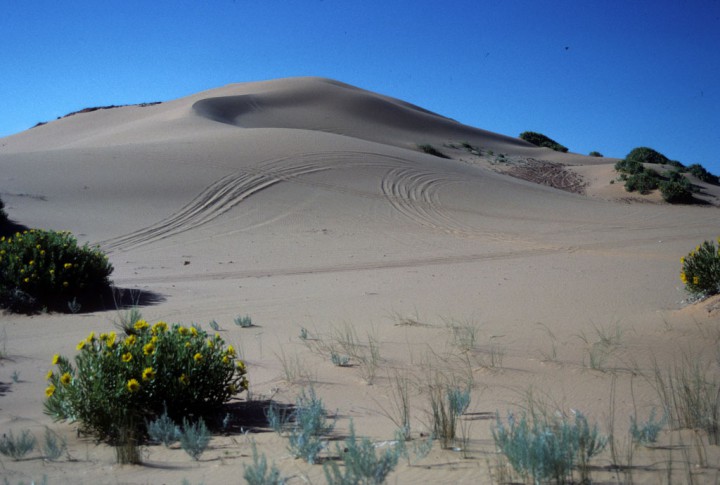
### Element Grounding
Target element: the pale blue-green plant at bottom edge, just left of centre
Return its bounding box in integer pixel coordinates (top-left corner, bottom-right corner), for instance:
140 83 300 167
323 421 403 485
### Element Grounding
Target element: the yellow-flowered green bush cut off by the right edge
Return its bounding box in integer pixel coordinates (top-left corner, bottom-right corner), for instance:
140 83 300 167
680 238 720 297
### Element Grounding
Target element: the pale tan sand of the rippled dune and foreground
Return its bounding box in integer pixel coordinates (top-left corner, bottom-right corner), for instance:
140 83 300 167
0 78 720 484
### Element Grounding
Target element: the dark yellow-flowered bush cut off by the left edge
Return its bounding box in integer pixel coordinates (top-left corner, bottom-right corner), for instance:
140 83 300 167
0 229 113 312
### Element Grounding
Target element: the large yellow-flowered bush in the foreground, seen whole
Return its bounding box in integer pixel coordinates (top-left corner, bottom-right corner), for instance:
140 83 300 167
44 320 248 442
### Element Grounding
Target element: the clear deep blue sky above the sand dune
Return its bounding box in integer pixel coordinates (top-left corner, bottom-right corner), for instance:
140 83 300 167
0 0 720 173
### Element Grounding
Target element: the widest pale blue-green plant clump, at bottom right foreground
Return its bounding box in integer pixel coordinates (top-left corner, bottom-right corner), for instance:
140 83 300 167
493 412 607 483
